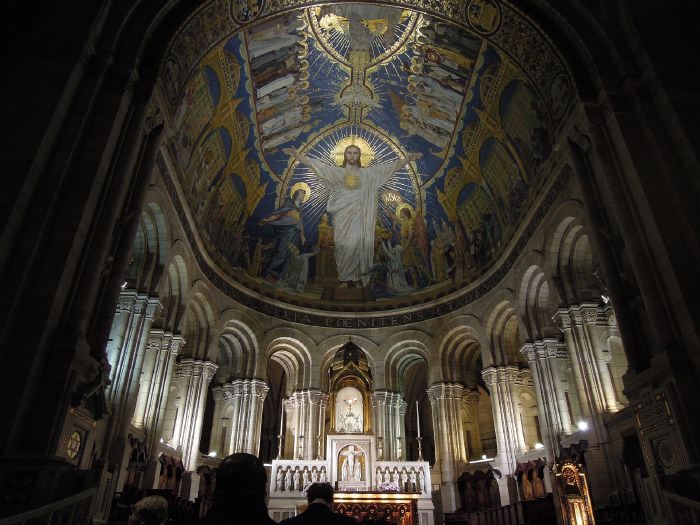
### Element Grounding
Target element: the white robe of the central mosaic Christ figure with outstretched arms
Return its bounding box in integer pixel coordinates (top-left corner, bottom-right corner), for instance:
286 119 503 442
309 159 402 286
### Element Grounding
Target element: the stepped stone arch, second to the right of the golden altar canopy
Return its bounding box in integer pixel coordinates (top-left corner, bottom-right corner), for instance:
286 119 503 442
433 315 482 386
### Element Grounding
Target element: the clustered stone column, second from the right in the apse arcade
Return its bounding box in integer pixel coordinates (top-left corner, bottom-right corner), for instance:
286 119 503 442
520 339 571 462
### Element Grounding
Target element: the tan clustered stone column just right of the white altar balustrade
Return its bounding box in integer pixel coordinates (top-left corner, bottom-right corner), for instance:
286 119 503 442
427 383 467 512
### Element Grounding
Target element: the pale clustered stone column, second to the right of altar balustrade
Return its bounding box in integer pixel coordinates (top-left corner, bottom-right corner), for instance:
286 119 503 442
481 366 525 505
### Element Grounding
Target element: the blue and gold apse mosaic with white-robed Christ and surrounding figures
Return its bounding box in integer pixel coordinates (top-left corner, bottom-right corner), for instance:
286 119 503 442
162 0 569 309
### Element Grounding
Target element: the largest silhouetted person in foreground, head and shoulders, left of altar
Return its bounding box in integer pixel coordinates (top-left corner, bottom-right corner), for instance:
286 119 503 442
196 453 277 525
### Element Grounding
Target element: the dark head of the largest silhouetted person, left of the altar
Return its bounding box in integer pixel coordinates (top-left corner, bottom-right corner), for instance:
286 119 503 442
214 452 267 498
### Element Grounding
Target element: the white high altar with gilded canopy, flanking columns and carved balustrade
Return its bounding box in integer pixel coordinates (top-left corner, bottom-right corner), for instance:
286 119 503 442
268 341 434 525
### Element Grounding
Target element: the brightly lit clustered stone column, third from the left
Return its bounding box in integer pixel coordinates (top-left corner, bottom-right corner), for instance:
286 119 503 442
175 357 218 471
